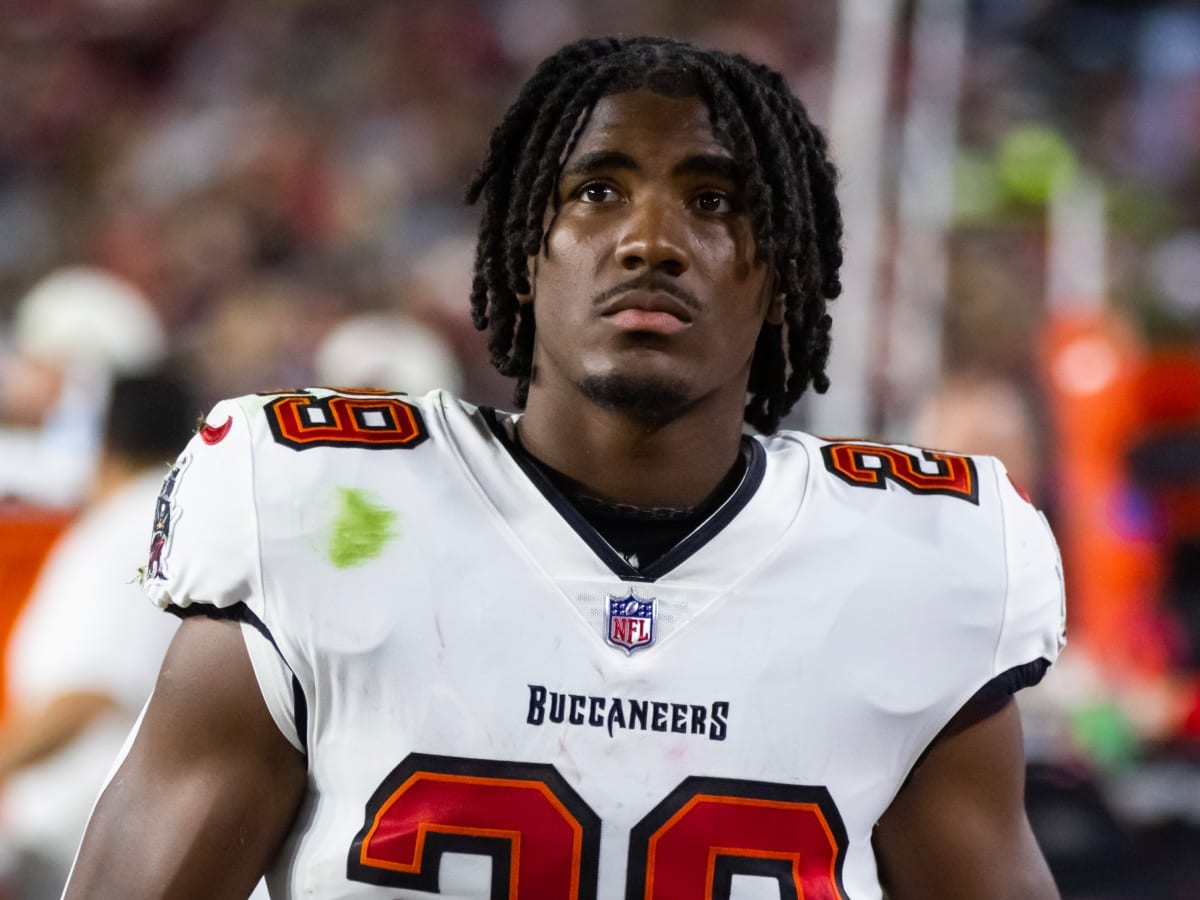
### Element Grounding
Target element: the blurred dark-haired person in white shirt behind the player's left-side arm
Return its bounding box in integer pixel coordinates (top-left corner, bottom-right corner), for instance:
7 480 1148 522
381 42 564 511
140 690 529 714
0 374 198 900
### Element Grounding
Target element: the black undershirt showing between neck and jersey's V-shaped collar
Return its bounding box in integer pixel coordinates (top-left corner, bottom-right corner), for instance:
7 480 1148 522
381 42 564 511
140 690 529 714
512 437 748 569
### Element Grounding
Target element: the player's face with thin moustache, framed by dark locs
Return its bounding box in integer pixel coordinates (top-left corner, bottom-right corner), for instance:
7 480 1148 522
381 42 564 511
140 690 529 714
530 90 782 425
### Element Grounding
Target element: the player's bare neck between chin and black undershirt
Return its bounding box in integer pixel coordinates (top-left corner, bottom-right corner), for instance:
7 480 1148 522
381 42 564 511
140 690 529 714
520 390 742 509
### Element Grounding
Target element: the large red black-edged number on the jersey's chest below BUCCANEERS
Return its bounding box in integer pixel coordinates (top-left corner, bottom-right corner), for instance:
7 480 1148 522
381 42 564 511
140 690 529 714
347 754 846 900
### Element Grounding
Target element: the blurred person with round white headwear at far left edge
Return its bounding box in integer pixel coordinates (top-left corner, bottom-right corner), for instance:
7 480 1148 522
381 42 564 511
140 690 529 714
0 266 167 505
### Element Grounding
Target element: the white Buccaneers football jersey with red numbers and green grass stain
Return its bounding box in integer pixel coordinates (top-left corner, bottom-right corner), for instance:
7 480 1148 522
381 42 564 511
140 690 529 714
146 389 1063 900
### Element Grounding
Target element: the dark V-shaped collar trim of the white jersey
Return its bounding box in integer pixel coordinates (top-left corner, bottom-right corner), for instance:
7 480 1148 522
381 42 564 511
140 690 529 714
479 407 767 582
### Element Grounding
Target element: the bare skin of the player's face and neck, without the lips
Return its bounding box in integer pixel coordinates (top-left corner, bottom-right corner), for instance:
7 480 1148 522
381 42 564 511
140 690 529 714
520 90 782 506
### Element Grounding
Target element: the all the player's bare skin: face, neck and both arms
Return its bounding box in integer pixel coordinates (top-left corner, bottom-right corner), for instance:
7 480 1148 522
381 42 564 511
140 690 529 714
66 90 1058 900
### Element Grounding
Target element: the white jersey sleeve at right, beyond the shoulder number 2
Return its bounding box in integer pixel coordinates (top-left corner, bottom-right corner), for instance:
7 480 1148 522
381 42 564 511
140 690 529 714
992 461 1067 690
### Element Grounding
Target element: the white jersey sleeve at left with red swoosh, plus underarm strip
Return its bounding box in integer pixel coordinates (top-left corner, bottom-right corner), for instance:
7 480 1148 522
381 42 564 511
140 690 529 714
144 400 302 749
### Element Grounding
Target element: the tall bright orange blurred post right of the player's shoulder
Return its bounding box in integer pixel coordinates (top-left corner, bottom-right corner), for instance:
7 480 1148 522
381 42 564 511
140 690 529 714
1043 310 1170 680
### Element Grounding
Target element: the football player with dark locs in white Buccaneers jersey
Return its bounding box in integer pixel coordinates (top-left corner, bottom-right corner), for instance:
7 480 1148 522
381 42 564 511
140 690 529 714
67 38 1063 900
